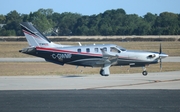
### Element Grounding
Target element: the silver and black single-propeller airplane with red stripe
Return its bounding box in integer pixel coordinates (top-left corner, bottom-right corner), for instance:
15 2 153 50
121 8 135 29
19 22 168 76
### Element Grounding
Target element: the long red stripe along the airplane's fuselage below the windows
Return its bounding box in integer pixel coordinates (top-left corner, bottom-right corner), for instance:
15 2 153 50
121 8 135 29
36 47 102 56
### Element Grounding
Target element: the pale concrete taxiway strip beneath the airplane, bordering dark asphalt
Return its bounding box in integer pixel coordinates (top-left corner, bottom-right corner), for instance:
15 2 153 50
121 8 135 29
0 71 180 90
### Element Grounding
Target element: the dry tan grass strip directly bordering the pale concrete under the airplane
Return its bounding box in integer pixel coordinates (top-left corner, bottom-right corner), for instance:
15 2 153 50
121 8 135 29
0 62 180 76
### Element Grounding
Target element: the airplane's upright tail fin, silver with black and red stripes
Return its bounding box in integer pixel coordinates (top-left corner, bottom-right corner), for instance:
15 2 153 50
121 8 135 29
20 22 52 47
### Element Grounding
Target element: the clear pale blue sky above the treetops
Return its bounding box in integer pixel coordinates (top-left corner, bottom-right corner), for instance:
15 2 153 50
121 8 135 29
0 0 180 16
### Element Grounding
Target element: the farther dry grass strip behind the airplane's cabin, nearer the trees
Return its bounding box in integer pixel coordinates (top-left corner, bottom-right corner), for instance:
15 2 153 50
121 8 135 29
0 41 180 58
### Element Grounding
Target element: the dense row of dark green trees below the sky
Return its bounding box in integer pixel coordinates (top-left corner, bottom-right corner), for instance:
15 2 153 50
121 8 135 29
0 9 180 36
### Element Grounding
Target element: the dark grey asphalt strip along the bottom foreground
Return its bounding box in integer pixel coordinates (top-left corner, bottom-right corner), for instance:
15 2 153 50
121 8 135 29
0 89 180 112
